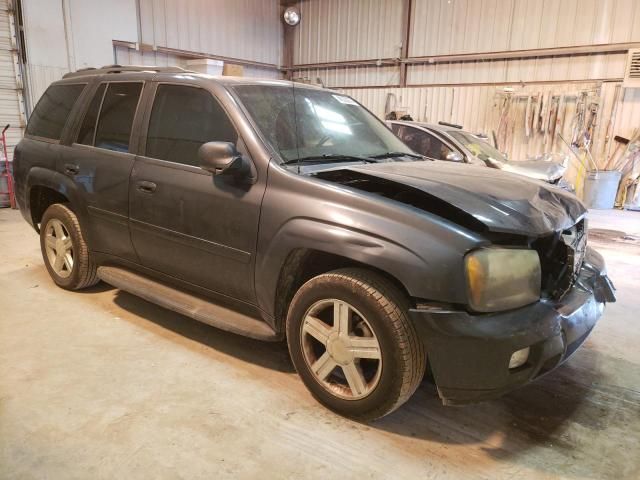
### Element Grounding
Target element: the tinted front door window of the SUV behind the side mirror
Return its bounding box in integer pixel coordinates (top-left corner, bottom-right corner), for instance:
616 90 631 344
145 85 238 165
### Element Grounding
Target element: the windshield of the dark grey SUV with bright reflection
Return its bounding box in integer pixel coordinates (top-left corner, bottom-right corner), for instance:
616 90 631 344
234 85 415 162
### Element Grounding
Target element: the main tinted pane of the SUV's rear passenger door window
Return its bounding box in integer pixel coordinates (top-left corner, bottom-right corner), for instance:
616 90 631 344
94 82 142 152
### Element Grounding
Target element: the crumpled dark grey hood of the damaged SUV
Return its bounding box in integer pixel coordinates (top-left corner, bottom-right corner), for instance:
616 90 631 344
345 161 586 236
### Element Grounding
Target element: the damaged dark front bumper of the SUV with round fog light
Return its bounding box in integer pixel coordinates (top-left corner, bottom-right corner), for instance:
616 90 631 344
409 248 615 405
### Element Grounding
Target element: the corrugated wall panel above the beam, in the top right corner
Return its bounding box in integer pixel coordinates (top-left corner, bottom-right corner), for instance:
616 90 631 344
409 0 640 56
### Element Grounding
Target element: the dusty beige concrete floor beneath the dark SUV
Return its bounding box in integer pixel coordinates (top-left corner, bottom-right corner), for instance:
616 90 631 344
0 209 640 479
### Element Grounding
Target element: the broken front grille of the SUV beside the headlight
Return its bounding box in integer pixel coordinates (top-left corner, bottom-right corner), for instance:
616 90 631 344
533 219 587 300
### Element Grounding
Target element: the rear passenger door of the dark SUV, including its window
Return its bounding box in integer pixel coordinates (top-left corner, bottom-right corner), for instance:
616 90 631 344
64 81 143 262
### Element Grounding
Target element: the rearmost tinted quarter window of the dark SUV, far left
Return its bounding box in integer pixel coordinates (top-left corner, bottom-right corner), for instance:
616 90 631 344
27 84 85 140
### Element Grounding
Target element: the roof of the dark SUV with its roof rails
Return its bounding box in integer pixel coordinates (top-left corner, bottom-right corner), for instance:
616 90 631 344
56 65 322 90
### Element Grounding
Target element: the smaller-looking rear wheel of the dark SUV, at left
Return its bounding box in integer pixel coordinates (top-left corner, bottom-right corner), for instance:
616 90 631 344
40 203 99 290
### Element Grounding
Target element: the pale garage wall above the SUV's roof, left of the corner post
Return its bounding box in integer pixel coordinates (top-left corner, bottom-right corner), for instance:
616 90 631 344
21 0 282 106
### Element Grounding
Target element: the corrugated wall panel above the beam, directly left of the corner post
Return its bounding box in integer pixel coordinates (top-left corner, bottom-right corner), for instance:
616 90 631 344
140 0 282 65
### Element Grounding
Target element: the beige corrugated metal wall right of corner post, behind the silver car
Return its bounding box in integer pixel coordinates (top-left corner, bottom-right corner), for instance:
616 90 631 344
291 0 640 191
